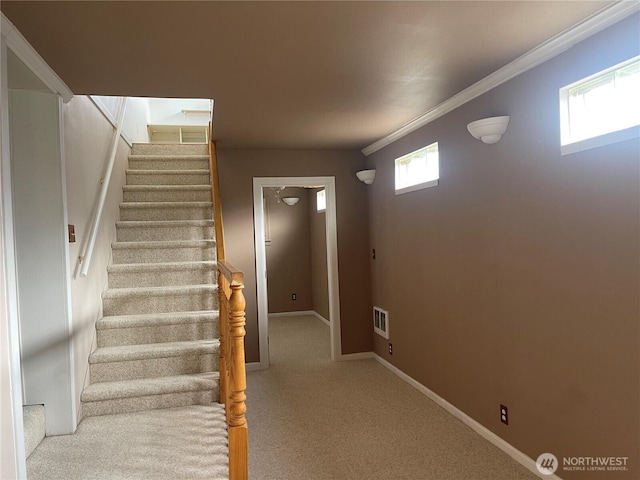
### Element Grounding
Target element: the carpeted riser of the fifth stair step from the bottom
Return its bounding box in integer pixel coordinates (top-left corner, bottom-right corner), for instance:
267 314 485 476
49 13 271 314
109 268 216 288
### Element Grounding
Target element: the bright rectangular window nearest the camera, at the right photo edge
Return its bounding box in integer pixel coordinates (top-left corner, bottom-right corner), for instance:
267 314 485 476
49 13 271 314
560 56 640 154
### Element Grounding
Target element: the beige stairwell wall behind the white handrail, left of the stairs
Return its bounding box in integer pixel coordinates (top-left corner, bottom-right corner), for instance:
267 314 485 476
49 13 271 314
64 96 129 418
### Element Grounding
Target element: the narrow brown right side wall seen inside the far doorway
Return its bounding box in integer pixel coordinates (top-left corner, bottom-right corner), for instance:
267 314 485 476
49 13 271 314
309 189 329 320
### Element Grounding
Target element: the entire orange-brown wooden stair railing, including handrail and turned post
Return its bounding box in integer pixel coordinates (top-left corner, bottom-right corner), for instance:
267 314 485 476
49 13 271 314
209 142 248 480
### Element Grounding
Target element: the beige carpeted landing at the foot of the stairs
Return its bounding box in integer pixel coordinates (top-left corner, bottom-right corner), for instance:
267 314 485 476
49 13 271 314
27 404 229 480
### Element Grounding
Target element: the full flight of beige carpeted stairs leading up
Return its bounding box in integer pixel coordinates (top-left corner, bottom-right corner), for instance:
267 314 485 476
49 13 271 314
81 144 224 417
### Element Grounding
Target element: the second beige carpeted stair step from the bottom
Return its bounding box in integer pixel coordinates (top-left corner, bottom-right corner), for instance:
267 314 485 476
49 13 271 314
89 339 220 384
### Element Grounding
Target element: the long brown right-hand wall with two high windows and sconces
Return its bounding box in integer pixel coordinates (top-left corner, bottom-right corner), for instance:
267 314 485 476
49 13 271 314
368 15 640 480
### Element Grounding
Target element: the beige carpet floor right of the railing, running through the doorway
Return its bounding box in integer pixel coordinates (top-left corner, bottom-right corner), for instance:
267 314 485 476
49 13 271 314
247 316 537 480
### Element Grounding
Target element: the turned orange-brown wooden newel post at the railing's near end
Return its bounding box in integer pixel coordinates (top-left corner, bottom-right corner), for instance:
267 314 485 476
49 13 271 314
227 282 248 480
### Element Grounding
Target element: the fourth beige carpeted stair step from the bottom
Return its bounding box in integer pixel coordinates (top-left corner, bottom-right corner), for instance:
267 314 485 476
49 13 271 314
102 285 218 316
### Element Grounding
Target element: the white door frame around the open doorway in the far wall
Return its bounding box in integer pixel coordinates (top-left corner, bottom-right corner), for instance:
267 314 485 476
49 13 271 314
253 177 342 369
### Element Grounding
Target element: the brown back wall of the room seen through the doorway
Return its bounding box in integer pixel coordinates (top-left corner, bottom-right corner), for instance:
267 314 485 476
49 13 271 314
263 187 312 313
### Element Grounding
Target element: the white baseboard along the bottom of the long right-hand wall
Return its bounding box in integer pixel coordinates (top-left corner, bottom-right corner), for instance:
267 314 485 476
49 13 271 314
372 352 562 480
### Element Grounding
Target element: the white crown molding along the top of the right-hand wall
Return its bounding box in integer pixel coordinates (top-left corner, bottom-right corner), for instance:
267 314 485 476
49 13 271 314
362 0 640 156
